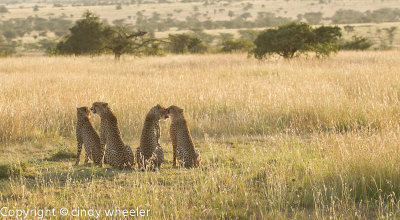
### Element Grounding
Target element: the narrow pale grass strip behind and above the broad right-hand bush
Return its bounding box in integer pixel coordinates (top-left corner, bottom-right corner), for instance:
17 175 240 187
129 8 400 32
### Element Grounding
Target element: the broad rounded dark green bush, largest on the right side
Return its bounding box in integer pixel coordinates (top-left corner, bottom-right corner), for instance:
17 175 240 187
252 22 341 59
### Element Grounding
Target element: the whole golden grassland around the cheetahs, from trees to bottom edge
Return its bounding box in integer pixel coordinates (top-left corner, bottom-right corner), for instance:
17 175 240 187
0 51 400 219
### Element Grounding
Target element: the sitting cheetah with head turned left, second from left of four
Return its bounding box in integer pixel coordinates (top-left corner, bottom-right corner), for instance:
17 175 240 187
91 102 134 169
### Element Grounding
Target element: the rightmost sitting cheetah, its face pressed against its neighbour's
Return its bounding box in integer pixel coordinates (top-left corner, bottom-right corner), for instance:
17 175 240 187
167 105 201 168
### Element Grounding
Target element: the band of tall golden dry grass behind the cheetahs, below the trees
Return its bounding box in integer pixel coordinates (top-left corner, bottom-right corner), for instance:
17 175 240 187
0 51 400 143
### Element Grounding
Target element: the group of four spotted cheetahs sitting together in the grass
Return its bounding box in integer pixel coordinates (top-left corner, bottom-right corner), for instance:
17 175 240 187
75 102 201 170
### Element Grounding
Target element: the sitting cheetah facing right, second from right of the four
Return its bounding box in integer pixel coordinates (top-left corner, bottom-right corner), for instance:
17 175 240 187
136 105 167 170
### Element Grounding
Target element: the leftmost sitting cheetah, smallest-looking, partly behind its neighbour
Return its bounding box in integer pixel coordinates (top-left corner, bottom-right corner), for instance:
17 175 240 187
75 107 104 167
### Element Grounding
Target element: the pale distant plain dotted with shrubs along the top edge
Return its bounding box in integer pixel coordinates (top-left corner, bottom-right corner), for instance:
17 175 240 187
2 0 398 22
